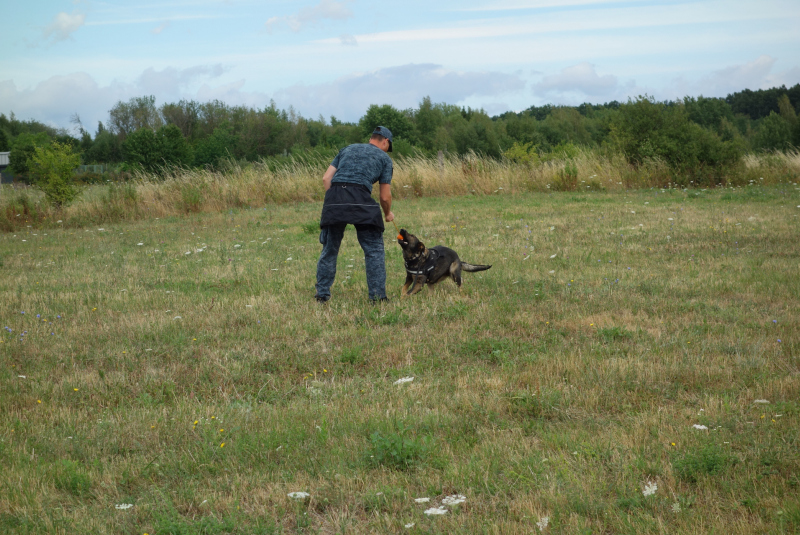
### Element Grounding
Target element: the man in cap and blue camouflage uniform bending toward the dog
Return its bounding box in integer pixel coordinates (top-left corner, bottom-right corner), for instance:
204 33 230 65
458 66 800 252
314 126 394 303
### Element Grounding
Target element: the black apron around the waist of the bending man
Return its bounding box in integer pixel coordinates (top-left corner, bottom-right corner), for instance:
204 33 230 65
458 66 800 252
319 182 384 232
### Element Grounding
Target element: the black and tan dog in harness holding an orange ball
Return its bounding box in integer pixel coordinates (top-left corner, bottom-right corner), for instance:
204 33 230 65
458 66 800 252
397 229 492 297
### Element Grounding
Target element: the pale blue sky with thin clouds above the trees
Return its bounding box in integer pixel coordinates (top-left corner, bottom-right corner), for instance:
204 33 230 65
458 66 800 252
0 0 800 133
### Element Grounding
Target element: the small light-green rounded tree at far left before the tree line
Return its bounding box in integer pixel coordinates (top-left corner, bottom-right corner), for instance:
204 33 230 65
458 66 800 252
30 141 81 209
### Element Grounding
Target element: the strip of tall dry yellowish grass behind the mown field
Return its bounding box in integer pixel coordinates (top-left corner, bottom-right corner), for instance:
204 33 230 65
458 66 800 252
0 149 800 231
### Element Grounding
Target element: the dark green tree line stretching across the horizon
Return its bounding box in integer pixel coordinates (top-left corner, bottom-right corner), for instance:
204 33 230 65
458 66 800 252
0 84 800 180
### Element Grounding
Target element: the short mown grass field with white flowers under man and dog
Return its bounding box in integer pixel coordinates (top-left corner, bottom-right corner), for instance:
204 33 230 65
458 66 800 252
0 184 800 535
